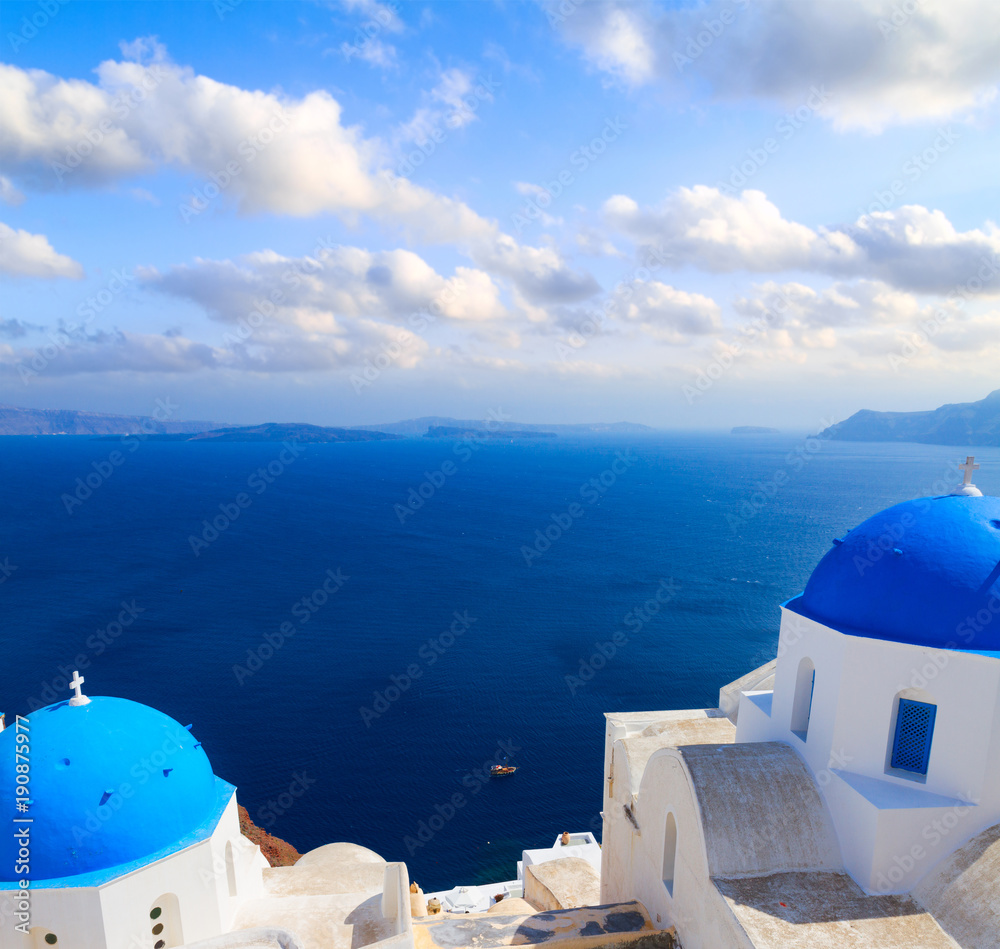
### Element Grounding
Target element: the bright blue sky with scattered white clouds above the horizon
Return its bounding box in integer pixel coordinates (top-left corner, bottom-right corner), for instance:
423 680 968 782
0 0 1000 431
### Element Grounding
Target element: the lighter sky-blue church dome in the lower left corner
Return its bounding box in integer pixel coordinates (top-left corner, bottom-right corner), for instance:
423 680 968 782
0 697 218 882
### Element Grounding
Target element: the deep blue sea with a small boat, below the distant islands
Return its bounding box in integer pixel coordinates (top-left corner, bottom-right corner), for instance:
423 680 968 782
0 434 1000 891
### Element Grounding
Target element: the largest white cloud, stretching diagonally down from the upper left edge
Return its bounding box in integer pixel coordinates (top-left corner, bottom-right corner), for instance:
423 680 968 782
0 42 597 302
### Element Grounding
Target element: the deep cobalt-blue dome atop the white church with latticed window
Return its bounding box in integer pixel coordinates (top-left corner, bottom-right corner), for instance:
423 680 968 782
788 496 1000 652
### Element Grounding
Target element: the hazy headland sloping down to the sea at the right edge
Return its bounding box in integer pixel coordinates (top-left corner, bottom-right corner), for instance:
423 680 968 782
819 389 1000 447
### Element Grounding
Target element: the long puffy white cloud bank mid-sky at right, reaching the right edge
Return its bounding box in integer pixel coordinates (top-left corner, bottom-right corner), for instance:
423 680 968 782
604 185 1000 295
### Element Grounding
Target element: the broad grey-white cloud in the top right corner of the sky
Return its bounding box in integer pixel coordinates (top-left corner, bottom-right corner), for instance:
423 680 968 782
548 0 1000 131
